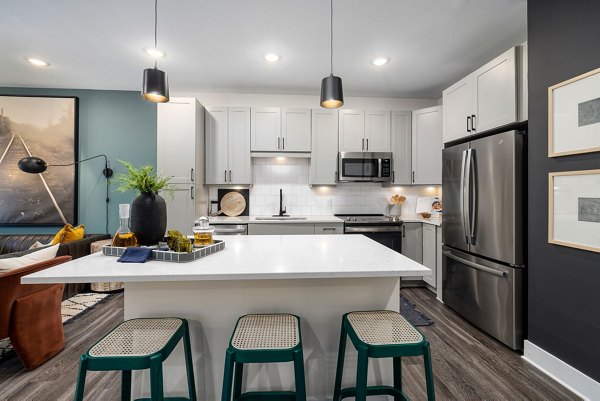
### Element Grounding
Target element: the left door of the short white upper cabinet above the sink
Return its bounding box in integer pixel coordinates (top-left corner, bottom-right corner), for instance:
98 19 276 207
250 107 282 152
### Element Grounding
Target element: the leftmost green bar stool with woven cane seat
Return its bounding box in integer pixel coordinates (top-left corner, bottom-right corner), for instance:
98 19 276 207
75 318 196 401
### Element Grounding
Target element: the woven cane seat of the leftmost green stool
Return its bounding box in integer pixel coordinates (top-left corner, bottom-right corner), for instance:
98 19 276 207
89 318 183 357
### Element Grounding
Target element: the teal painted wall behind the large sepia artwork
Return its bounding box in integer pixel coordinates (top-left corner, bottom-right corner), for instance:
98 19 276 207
0 88 156 234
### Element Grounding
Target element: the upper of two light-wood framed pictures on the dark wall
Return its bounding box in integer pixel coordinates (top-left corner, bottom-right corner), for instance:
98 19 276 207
548 68 600 157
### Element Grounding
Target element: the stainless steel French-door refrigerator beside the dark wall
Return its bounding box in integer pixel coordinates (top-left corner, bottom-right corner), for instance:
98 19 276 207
442 131 525 349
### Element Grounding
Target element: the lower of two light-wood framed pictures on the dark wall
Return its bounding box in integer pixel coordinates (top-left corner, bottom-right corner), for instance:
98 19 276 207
548 170 600 252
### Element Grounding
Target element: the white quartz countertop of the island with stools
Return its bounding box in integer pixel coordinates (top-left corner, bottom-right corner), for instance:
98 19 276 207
21 235 431 284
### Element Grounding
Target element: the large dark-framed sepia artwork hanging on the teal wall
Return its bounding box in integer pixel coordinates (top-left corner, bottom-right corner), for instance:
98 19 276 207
0 95 78 225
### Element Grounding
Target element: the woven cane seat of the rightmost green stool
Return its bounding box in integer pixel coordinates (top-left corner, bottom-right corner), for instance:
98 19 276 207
348 310 423 345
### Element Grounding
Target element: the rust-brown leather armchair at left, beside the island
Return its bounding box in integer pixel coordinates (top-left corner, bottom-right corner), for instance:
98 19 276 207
0 256 71 369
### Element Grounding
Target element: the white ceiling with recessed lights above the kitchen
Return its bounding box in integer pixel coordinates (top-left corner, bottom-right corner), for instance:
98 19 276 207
0 0 527 98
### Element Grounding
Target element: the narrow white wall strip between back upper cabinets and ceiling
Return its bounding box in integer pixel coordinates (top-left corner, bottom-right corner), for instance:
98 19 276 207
171 92 441 110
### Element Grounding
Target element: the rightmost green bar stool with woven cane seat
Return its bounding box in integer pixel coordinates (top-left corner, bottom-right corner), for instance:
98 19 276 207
333 310 435 401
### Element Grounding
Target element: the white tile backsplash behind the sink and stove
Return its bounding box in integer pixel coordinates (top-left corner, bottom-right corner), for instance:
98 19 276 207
209 157 441 216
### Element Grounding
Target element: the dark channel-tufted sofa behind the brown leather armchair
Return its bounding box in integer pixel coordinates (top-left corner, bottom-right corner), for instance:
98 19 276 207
0 234 110 299
